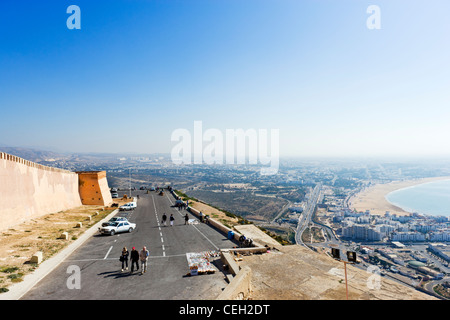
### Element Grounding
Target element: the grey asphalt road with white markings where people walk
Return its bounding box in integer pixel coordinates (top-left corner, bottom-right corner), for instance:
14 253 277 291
22 191 236 300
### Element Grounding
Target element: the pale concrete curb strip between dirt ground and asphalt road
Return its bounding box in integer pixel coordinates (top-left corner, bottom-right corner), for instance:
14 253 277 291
0 209 119 300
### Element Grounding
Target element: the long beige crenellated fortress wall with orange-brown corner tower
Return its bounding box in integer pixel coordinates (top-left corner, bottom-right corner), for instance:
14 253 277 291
0 152 112 230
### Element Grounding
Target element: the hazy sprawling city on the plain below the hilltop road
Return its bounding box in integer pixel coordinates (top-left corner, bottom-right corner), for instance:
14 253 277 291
2 148 450 298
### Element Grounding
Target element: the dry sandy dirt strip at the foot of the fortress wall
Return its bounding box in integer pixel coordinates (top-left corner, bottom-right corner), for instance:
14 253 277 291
0 199 129 294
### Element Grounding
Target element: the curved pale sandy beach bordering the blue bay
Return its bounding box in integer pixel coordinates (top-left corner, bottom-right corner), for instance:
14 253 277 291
349 177 450 216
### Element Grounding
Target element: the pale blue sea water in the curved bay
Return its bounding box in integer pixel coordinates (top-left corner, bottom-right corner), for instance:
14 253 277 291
386 180 450 217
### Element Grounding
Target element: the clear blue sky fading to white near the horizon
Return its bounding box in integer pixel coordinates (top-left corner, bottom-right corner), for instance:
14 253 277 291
0 0 450 156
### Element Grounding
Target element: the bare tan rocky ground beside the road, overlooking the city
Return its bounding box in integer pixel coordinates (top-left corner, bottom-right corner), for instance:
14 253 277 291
240 245 436 300
